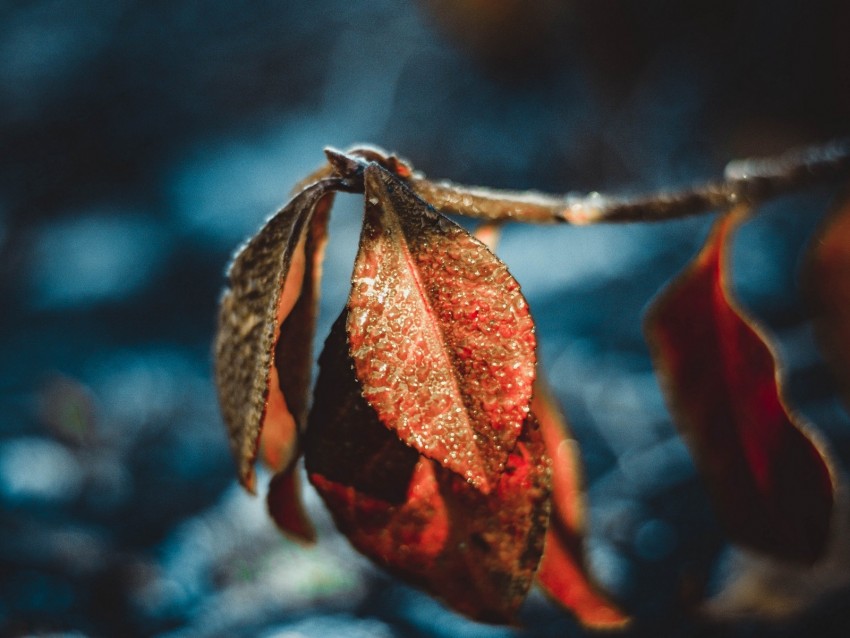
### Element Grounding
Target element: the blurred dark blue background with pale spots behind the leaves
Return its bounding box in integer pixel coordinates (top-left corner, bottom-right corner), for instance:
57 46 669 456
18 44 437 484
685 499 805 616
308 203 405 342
0 0 850 638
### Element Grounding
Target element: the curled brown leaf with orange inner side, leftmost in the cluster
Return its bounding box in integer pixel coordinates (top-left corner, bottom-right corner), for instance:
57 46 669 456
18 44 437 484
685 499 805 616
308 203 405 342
215 179 339 492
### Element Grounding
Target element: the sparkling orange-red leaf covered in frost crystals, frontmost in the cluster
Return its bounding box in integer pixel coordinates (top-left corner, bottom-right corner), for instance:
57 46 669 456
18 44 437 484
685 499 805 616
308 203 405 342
347 163 536 492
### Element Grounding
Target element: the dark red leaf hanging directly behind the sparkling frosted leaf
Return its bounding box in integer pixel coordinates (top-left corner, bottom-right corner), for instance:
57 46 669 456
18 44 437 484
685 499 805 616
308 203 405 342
305 314 549 622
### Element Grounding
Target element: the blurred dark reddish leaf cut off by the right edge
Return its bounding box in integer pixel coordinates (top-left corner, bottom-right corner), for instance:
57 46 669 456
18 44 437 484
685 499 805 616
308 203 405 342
805 190 850 407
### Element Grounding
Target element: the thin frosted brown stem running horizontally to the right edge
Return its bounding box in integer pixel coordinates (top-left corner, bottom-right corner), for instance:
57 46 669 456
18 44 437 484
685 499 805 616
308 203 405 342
409 139 850 225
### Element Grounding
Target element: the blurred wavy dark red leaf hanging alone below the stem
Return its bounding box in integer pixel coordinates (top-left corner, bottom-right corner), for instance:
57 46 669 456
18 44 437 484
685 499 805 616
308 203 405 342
645 208 834 564
